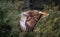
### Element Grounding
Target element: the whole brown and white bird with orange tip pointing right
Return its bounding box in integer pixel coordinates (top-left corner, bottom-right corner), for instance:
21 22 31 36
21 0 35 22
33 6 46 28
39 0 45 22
20 10 49 32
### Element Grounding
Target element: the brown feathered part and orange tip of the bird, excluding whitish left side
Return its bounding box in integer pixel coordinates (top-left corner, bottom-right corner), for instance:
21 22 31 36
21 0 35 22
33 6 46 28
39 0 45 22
21 10 48 31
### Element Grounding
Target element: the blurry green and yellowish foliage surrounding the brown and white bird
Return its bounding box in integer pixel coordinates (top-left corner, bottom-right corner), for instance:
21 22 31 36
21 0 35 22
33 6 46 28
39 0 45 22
0 0 60 37
